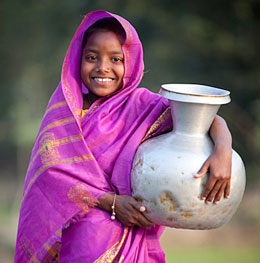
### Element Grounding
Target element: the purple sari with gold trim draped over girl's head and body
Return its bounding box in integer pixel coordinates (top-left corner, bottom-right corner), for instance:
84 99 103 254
15 11 172 263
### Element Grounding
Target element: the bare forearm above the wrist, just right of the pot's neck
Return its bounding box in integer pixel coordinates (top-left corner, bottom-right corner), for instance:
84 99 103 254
209 115 232 149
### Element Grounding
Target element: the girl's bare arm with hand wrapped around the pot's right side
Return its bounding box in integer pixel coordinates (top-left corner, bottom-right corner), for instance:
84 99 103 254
194 116 232 204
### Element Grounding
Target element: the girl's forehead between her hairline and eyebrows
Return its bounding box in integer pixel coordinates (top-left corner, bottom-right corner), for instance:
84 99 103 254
84 31 122 52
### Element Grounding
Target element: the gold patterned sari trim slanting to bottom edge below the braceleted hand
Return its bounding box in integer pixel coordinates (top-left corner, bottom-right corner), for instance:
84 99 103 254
94 227 129 263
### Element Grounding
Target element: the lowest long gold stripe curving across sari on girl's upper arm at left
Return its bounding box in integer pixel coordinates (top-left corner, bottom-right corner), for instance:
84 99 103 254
22 154 94 202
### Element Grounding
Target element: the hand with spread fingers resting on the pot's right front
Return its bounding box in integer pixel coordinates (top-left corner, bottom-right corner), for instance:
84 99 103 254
194 146 232 204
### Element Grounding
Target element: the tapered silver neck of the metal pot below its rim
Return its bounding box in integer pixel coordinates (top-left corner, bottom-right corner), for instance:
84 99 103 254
169 100 220 137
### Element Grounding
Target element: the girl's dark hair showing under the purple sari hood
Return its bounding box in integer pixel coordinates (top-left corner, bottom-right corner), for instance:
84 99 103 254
82 17 126 50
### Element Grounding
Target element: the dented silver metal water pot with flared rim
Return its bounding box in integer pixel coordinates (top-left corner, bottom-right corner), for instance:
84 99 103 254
131 84 246 229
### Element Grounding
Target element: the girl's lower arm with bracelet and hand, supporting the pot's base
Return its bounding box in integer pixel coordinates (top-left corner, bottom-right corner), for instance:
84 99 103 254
97 193 153 227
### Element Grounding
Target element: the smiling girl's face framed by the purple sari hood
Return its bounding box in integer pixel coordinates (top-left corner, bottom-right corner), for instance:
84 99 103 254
80 32 125 97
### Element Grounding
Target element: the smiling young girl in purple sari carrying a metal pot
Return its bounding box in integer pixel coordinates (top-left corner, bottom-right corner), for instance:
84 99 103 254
15 11 231 263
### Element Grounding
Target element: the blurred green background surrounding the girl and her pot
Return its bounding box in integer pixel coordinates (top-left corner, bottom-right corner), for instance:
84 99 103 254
0 0 260 263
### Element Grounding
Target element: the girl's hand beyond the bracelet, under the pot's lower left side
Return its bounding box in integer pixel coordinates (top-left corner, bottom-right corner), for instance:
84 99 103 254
115 195 154 227
